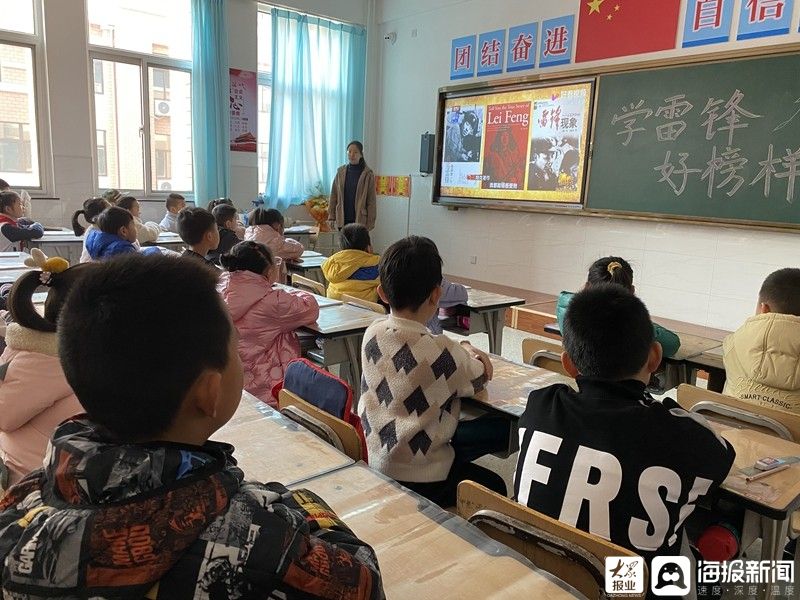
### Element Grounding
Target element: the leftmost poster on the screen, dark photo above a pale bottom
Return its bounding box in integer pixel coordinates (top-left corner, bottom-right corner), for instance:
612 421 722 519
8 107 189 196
442 104 485 189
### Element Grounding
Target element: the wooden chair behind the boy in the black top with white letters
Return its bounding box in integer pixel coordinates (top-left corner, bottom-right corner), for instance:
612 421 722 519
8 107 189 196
458 481 648 599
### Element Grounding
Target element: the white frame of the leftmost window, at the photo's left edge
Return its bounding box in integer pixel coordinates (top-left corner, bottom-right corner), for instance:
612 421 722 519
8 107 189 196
0 0 54 192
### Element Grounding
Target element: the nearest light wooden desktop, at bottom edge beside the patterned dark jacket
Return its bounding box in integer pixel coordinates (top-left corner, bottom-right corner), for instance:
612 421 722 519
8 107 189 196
295 463 579 600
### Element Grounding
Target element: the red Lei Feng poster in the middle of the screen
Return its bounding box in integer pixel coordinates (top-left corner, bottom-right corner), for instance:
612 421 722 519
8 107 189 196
481 102 531 190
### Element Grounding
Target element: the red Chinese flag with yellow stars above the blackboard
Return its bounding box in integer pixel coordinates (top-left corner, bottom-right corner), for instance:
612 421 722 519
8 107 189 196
575 0 681 62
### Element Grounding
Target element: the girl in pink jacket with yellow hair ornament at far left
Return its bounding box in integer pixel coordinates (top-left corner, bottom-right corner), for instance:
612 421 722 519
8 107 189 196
0 248 94 487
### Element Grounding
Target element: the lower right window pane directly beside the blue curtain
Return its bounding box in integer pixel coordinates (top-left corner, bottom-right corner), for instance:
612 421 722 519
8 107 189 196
149 67 192 192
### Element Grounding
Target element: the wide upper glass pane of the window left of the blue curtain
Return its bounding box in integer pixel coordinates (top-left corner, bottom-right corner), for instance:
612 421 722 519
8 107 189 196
87 0 192 60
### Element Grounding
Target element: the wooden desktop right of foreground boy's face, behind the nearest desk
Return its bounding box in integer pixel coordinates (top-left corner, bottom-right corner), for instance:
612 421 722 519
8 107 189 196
211 392 353 486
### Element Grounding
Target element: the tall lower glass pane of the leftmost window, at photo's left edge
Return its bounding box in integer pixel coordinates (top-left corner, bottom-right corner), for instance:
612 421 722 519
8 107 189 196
0 44 41 187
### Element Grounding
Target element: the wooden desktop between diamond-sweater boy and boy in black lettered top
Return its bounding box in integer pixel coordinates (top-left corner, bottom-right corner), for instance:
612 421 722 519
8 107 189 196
472 355 575 419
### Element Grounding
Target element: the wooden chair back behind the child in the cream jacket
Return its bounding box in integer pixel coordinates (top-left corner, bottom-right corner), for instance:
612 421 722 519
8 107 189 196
677 383 800 442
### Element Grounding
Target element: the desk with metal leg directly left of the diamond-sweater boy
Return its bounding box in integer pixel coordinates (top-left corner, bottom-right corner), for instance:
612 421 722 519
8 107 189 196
301 304 386 389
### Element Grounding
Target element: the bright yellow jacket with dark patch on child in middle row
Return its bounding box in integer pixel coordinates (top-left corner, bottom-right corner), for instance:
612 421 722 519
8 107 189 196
322 250 381 302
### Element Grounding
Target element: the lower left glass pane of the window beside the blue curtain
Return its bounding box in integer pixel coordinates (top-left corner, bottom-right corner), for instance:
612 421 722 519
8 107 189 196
94 59 144 190
